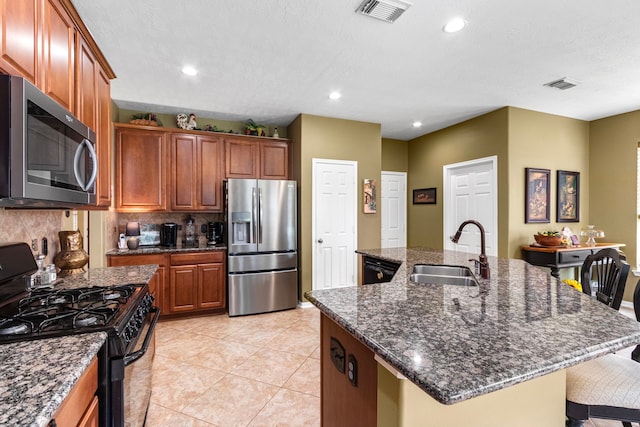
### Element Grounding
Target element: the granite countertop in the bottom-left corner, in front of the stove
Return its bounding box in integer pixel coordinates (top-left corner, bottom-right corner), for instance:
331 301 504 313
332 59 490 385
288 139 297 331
0 332 107 427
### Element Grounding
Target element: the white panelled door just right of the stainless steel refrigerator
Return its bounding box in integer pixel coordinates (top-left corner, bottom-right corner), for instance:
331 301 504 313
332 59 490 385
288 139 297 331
311 159 358 290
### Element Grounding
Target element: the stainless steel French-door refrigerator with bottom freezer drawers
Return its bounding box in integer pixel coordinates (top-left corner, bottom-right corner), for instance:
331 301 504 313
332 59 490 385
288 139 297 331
225 179 298 316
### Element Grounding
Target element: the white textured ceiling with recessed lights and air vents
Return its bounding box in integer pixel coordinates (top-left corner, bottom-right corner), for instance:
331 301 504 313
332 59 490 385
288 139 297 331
73 0 640 140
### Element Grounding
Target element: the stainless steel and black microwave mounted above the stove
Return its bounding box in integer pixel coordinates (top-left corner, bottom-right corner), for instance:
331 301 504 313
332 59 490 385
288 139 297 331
0 75 98 208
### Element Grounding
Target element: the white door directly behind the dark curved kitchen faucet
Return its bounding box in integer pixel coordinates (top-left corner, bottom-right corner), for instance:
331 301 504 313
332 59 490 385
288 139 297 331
443 156 498 256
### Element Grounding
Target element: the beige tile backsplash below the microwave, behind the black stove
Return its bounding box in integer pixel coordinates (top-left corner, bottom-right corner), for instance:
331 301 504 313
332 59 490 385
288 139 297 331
0 209 64 265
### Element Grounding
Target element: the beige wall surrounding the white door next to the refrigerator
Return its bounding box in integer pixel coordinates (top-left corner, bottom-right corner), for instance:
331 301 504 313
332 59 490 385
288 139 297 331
288 114 382 299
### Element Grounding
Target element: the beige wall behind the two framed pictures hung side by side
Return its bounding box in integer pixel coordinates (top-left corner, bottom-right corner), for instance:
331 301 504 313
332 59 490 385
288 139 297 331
500 107 590 258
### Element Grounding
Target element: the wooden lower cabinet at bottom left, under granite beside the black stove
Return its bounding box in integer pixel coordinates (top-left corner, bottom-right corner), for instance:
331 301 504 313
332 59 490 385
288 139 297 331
49 356 98 427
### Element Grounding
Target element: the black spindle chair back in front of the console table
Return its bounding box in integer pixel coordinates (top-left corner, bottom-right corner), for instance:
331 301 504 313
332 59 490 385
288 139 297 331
581 248 638 310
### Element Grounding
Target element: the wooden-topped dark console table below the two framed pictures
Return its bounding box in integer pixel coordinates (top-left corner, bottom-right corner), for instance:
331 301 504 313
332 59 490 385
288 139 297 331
522 243 624 279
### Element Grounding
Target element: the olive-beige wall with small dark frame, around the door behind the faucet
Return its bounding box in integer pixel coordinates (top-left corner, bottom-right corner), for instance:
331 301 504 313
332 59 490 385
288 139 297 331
407 108 509 256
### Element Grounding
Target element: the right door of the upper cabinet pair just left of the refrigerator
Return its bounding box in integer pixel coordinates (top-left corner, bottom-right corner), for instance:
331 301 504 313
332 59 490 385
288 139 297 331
196 136 222 212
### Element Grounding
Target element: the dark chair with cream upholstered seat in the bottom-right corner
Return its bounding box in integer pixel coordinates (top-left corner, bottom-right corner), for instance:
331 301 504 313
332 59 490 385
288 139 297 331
566 280 640 427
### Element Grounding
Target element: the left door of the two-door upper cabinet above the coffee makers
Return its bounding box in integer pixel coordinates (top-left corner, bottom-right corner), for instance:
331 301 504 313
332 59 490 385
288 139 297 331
169 134 198 210
